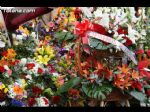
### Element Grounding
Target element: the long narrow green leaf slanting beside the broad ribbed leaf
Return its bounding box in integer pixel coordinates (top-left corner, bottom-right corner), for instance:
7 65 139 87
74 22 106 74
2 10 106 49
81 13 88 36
57 77 81 94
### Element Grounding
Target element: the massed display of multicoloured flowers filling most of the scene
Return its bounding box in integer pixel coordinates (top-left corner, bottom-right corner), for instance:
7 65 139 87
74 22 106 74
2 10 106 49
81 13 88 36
0 7 150 107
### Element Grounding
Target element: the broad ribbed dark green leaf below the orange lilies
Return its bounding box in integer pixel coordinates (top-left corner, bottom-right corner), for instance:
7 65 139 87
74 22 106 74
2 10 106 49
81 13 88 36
82 84 112 100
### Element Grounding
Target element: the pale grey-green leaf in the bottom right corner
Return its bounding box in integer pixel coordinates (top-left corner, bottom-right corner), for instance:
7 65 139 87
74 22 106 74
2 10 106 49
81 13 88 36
130 91 147 102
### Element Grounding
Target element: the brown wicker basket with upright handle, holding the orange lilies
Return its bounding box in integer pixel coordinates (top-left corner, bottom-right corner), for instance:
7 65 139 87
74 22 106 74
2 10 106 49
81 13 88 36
75 39 132 102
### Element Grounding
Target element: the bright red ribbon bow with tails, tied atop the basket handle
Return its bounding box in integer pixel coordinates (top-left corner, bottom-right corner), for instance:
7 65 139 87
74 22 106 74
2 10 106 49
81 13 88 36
74 19 107 53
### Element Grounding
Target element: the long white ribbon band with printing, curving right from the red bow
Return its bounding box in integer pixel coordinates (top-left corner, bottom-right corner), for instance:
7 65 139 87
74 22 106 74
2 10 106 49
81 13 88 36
87 31 137 65
